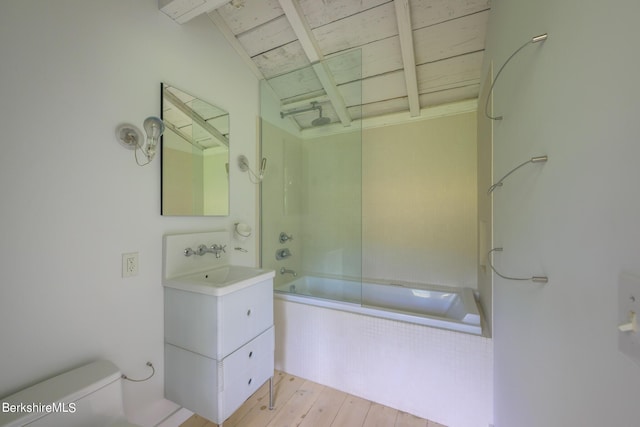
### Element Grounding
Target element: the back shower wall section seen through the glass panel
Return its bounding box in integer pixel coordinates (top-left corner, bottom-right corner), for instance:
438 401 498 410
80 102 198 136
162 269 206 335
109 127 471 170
301 132 363 278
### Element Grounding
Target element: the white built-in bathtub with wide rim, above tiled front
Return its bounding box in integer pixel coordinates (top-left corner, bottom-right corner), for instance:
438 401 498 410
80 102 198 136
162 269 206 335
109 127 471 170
274 276 482 335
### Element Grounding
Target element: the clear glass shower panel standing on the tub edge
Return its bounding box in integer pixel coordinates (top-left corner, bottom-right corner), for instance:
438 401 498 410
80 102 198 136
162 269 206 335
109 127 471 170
260 51 362 304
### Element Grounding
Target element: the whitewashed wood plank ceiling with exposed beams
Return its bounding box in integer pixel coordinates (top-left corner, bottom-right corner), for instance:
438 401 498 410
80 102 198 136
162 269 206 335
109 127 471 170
165 0 490 128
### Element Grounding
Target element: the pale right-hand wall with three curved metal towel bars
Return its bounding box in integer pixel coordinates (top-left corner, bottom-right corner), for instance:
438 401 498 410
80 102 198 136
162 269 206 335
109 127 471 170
485 0 640 427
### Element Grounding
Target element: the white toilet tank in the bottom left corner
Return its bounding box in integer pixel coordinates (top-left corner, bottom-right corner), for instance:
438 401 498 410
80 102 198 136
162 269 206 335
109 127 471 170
0 360 139 427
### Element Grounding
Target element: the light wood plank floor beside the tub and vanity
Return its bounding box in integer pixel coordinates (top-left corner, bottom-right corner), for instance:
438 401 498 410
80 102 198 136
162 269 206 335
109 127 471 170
180 372 445 427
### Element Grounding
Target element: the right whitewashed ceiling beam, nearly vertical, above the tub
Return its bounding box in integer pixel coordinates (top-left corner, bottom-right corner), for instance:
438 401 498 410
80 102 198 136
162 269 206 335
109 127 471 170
394 0 420 117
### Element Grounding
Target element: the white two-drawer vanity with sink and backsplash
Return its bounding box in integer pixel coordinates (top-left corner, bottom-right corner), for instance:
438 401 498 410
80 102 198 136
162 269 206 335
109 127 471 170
163 232 275 424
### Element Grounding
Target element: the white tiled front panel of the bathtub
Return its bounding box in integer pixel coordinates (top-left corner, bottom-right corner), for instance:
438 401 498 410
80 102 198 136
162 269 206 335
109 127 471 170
274 299 493 427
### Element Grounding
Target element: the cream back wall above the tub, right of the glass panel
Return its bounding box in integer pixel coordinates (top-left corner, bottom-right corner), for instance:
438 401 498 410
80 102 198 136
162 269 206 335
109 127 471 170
362 113 477 288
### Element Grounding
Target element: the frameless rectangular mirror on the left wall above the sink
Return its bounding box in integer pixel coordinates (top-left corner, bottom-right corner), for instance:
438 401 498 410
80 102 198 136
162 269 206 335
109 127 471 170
160 83 230 216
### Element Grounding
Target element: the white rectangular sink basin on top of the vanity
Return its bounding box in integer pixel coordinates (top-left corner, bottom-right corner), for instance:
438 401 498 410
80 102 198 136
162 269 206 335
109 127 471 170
164 265 275 296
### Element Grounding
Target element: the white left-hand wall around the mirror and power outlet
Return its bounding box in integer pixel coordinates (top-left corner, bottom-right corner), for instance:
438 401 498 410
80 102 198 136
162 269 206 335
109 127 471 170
0 0 258 420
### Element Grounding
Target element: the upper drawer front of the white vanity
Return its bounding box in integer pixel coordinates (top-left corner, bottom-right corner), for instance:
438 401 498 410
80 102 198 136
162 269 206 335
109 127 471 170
218 280 273 359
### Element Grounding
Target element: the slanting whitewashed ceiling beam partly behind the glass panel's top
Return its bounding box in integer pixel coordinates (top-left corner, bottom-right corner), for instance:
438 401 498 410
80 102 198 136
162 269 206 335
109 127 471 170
278 0 351 126
